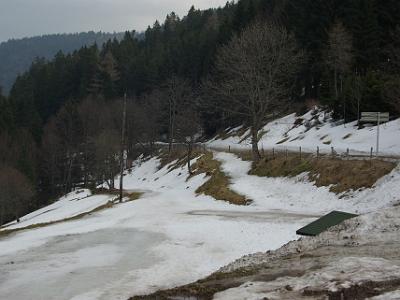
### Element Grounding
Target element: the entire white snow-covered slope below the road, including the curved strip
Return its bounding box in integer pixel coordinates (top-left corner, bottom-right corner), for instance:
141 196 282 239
0 153 400 300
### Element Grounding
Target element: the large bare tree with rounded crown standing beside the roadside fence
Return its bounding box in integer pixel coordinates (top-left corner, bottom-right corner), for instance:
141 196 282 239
205 21 303 162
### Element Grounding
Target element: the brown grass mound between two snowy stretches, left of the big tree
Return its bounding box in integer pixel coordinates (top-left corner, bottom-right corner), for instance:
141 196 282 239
193 152 249 205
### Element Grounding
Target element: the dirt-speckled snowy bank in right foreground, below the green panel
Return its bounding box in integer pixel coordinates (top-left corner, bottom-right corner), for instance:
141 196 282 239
214 207 400 300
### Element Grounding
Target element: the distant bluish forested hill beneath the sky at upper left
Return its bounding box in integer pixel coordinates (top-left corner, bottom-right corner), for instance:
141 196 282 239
0 32 122 93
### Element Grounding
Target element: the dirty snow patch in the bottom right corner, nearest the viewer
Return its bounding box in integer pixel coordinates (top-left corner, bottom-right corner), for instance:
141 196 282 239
214 257 400 300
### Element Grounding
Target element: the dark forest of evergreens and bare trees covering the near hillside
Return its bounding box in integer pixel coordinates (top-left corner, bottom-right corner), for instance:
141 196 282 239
0 0 400 224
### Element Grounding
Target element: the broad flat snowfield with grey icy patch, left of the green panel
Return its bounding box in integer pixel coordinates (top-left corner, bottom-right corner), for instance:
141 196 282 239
0 154 314 300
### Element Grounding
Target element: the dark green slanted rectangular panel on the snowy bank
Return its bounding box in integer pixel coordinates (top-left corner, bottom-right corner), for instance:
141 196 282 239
296 211 358 236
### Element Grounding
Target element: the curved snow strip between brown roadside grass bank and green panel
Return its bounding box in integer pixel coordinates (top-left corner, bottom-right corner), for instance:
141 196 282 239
215 152 400 215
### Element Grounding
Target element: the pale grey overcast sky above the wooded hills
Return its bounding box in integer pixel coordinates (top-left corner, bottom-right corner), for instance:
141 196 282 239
0 0 227 42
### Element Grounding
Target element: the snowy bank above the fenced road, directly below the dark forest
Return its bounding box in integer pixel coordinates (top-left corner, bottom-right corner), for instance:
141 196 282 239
208 109 400 155
